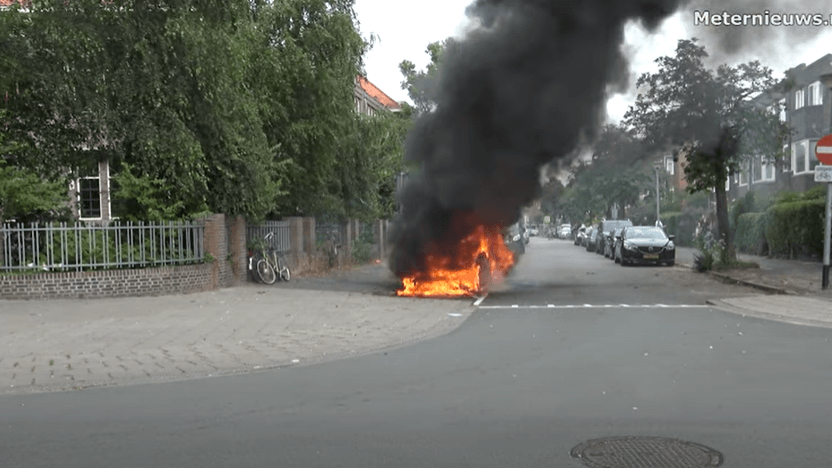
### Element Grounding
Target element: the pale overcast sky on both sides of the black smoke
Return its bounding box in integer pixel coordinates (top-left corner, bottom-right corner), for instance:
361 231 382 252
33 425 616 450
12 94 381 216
355 0 832 122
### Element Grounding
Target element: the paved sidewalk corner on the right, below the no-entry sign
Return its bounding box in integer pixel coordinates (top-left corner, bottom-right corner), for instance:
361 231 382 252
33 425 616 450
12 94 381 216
676 247 832 328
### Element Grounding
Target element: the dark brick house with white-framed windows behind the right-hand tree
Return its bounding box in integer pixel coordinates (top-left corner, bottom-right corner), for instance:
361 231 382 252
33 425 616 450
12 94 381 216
726 54 832 201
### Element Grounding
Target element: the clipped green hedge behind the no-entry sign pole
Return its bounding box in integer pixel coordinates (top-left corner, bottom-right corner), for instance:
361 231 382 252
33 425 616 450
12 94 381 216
765 198 826 258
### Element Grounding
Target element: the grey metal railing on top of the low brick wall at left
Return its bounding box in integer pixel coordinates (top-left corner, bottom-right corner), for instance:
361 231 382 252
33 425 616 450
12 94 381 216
0 222 205 271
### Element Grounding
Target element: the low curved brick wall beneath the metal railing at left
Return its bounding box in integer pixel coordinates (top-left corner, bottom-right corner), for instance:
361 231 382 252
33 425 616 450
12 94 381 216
0 264 213 299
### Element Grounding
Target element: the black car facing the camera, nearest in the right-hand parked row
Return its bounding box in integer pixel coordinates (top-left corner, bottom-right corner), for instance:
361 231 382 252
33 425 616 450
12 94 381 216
615 226 676 266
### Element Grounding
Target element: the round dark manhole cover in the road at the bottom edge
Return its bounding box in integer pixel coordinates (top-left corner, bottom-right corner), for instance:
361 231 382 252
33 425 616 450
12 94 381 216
570 437 722 468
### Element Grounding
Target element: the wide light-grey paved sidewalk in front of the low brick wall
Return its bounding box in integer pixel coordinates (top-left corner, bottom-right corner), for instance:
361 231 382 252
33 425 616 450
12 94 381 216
0 276 474 395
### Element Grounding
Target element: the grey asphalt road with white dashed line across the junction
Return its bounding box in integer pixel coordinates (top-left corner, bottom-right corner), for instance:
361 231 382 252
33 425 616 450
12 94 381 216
0 239 832 468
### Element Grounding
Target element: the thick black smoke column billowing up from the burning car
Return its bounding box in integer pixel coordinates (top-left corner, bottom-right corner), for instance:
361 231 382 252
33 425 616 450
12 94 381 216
391 0 679 276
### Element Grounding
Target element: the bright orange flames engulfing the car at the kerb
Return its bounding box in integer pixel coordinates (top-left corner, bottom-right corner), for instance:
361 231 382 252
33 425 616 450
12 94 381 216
396 226 514 296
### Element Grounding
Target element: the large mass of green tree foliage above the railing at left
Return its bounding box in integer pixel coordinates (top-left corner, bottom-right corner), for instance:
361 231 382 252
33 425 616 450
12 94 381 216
0 0 395 223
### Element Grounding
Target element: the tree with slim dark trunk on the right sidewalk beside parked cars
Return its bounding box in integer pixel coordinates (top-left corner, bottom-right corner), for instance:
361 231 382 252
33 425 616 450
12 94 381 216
625 39 789 263
